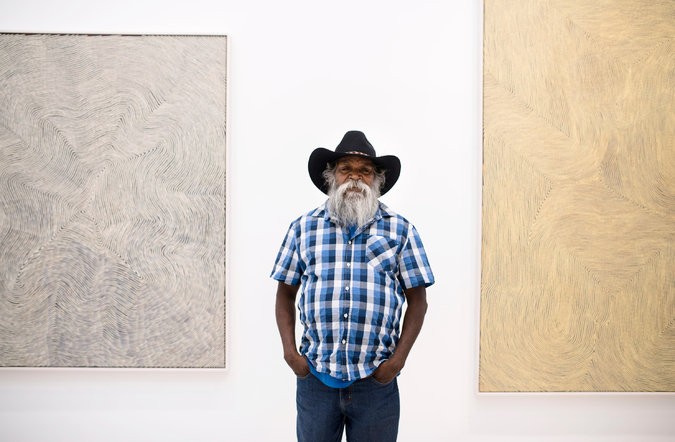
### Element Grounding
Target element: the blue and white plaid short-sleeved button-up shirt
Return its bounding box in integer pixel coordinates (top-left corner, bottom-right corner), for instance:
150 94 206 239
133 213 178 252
271 203 434 381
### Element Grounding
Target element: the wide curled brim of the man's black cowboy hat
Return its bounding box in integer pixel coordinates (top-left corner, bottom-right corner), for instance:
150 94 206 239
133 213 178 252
307 147 401 195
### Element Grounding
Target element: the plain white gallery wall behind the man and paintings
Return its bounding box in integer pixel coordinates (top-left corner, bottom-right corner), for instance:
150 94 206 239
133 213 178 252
0 0 675 442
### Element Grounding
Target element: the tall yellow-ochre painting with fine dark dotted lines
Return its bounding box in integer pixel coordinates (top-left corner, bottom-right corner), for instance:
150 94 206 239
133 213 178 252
479 0 675 391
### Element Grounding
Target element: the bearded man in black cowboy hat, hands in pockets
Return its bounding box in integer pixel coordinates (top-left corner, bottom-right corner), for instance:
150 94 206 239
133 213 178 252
271 131 434 442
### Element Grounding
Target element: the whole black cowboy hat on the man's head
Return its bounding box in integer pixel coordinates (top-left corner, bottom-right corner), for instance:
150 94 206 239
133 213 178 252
308 130 401 195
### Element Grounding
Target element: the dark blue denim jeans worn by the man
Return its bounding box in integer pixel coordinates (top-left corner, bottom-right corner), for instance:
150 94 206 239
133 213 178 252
296 373 400 442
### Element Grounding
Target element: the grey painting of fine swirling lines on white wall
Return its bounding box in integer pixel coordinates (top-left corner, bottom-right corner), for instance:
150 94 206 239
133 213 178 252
0 34 226 367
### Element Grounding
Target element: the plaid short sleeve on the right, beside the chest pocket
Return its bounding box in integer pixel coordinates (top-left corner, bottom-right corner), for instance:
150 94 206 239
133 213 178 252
398 225 435 289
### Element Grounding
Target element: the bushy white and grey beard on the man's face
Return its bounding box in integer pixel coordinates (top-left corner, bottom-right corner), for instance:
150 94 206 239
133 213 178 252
328 180 380 227
